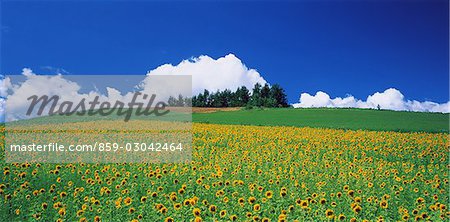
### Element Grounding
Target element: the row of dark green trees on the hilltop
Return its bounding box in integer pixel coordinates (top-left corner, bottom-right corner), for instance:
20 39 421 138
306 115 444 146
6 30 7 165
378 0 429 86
189 83 289 107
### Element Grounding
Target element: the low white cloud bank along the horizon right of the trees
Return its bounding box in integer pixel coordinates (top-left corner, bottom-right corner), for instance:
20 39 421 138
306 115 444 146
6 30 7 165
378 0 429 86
292 88 450 113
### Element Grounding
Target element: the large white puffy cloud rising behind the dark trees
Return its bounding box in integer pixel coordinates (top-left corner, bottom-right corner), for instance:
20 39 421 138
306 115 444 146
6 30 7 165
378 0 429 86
148 54 266 95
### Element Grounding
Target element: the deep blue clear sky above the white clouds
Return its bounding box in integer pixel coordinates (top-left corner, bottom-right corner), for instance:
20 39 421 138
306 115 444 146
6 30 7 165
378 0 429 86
0 0 449 102
